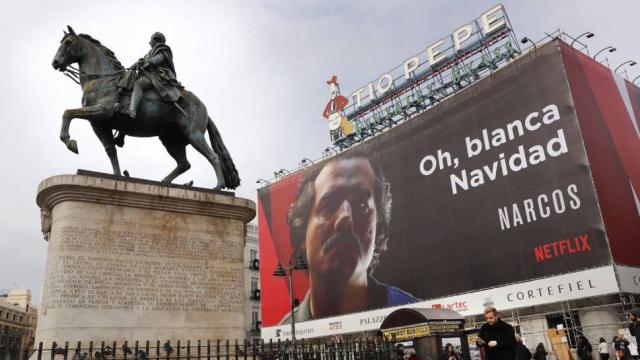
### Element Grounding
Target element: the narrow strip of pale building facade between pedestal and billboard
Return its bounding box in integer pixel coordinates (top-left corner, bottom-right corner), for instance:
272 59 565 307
244 223 261 340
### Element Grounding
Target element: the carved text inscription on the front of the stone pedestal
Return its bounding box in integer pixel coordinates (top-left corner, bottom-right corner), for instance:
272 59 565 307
41 226 243 313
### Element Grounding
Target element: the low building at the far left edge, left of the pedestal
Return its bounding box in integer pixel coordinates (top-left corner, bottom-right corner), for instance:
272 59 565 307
0 289 38 360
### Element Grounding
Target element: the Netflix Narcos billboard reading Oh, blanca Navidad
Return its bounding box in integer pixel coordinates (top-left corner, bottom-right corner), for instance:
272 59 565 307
258 43 611 327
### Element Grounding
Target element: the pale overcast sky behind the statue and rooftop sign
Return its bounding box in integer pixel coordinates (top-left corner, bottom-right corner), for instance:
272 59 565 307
0 0 640 302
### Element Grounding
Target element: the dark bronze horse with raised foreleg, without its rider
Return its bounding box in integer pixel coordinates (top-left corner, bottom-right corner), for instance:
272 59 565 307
52 26 240 190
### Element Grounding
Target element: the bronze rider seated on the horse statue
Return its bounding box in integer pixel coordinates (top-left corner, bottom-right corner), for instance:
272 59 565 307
115 32 182 146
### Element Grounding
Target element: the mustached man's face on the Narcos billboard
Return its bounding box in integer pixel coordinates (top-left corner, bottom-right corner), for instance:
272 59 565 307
303 157 377 281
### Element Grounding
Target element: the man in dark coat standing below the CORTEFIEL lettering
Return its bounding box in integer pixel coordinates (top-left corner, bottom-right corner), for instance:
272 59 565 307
477 307 516 360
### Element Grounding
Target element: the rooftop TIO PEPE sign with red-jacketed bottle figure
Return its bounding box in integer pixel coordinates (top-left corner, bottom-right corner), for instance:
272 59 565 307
323 5 519 147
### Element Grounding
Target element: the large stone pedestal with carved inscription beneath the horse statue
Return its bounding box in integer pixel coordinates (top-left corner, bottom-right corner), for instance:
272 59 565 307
36 172 255 348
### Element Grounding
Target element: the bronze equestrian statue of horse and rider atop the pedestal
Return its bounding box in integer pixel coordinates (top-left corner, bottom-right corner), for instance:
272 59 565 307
52 26 240 190
